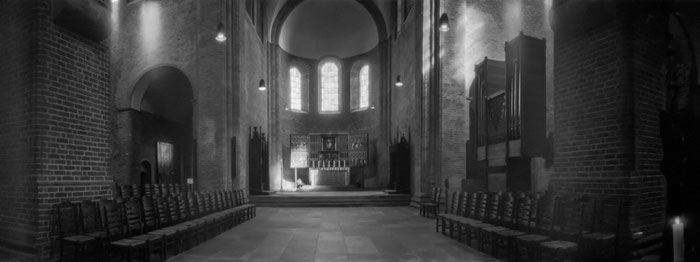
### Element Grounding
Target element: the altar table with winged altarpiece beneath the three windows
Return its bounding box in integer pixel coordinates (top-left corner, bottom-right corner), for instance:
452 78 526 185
290 134 367 186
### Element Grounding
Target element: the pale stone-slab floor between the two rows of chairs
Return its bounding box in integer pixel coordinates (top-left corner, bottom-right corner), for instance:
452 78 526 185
168 207 497 262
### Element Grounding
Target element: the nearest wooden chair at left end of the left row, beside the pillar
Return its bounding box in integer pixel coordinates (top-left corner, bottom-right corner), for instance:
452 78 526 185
55 201 97 261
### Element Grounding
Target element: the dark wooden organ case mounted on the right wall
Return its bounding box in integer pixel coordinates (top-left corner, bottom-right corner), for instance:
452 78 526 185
467 33 548 191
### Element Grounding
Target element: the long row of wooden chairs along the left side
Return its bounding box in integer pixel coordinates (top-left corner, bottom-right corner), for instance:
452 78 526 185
55 190 255 261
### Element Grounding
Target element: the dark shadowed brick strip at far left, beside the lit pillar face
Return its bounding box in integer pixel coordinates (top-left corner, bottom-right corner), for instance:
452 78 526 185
0 0 37 258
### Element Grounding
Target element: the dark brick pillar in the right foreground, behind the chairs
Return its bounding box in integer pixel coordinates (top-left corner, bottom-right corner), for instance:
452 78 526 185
552 1 665 234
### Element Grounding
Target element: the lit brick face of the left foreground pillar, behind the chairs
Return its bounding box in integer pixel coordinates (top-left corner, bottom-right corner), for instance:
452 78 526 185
30 1 114 258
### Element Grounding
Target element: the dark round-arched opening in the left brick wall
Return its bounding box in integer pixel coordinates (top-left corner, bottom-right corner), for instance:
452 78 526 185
128 66 194 184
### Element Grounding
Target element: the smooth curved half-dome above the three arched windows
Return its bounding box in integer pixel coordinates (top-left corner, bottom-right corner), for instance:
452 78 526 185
265 0 391 59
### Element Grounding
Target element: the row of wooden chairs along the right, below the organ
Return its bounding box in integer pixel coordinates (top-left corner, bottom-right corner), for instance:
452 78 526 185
436 192 625 261
